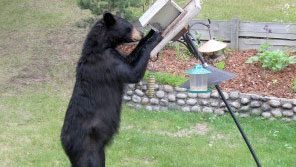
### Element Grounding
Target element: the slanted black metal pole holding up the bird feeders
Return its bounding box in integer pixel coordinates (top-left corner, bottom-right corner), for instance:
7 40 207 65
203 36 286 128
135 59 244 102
183 32 261 167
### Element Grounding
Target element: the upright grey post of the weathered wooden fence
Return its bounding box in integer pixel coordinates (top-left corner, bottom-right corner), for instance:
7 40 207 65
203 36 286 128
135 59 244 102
230 18 240 50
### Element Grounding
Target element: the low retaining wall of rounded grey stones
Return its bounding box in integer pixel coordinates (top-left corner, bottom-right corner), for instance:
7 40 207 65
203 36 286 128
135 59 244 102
123 82 296 121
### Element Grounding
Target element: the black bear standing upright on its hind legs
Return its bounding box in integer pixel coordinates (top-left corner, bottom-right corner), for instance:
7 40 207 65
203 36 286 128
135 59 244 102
61 13 162 167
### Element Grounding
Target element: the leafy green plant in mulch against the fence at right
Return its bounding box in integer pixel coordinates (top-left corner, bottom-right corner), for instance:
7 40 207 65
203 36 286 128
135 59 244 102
246 43 296 71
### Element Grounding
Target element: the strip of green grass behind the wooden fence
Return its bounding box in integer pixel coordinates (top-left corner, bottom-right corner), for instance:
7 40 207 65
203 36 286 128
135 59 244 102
180 0 296 23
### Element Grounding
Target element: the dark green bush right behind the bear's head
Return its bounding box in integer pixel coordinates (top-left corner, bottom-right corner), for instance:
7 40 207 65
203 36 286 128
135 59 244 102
77 0 146 20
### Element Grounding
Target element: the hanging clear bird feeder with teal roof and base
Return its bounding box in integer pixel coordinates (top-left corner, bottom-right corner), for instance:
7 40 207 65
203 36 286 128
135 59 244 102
186 64 212 93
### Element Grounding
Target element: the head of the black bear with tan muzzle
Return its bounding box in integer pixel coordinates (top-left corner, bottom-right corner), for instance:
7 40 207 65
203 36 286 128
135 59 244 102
102 12 143 45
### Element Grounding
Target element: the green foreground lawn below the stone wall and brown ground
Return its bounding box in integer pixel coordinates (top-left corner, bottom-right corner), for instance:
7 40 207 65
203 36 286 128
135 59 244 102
0 87 296 167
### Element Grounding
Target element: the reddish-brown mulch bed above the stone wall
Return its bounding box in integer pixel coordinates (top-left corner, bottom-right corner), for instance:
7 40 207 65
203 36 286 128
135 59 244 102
120 45 296 99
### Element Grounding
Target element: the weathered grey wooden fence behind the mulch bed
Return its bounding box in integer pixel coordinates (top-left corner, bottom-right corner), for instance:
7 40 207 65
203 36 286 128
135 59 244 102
190 19 296 51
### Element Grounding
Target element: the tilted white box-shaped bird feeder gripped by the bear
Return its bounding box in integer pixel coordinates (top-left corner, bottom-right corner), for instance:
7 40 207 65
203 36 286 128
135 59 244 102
139 0 201 57
